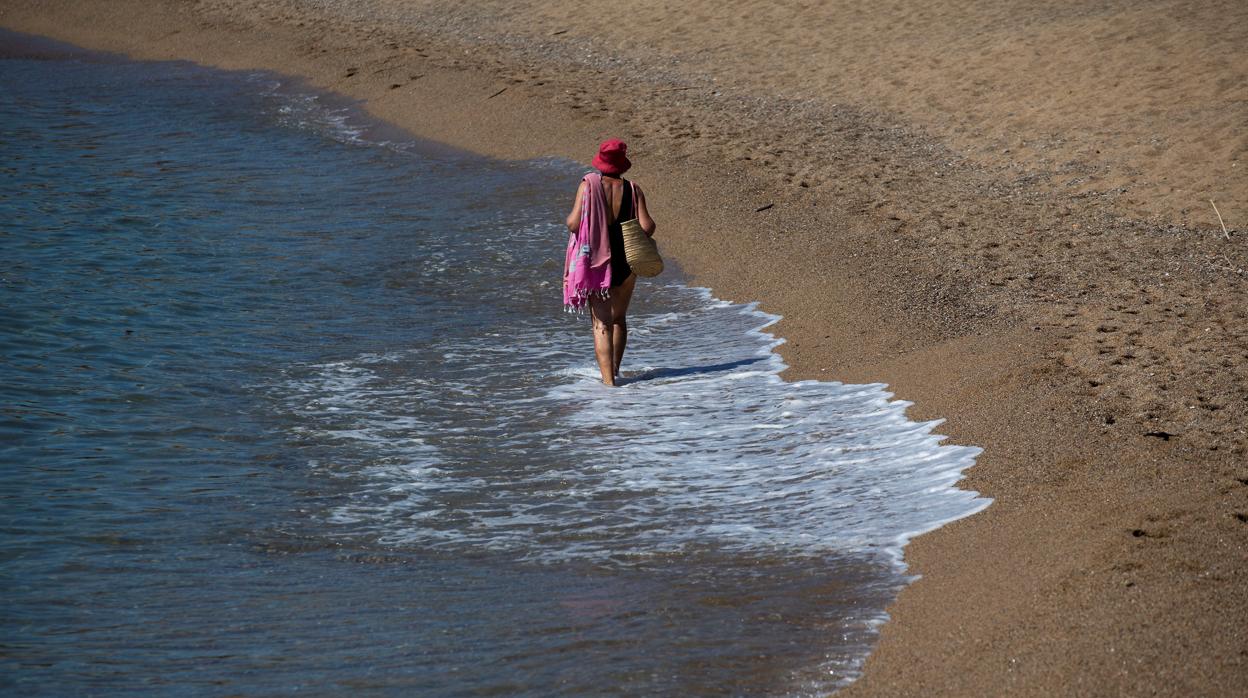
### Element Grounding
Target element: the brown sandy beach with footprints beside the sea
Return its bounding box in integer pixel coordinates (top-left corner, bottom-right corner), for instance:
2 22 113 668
0 0 1248 696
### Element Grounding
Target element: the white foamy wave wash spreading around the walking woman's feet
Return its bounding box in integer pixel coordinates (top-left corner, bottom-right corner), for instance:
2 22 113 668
268 285 988 576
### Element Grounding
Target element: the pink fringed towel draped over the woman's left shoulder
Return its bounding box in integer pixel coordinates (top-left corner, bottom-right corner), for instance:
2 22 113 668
563 172 612 311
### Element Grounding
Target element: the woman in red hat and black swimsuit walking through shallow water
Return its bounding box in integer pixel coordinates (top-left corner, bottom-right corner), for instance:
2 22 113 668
563 139 655 386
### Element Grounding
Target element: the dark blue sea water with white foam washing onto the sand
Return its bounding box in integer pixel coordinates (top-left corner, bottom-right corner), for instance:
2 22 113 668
0 35 986 696
